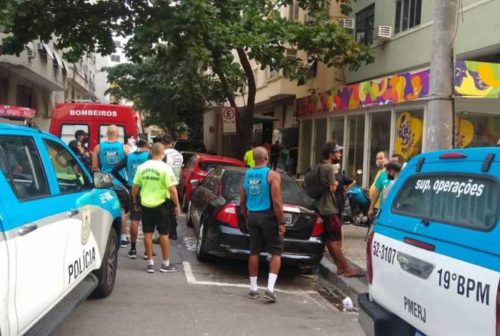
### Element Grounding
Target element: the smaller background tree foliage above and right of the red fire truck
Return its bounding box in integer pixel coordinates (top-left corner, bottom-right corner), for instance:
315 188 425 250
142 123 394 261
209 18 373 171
106 52 224 140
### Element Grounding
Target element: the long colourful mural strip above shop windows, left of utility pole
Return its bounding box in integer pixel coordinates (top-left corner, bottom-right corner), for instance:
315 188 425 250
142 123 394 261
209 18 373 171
296 69 429 117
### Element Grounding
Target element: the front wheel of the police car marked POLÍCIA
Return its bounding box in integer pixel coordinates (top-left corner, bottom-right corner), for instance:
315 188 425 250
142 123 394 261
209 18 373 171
90 228 118 298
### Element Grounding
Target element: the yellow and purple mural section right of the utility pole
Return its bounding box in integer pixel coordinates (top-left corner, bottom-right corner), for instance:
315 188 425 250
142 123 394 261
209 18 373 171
455 61 500 98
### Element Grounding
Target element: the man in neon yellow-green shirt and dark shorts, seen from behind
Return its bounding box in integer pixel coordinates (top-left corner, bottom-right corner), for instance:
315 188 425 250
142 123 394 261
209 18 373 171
132 143 180 273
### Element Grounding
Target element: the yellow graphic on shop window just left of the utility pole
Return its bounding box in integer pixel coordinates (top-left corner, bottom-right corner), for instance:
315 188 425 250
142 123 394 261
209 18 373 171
394 112 422 160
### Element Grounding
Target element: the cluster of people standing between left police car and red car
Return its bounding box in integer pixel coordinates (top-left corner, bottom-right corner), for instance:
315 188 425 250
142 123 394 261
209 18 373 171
69 125 183 273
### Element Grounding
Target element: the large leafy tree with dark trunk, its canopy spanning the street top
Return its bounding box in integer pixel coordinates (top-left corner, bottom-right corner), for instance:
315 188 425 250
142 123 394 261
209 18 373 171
0 0 372 150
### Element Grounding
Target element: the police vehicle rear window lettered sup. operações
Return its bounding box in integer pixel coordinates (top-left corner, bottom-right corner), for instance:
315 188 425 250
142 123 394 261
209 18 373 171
392 174 499 231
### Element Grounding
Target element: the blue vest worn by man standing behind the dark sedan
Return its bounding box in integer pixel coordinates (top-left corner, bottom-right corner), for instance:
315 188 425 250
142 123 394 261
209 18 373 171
243 167 272 212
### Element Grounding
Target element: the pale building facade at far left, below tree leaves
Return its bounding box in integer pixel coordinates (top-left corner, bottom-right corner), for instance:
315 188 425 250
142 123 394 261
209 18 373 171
0 34 95 130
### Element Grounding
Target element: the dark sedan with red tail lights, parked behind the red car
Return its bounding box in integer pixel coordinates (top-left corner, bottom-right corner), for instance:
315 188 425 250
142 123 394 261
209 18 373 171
187 166 324 267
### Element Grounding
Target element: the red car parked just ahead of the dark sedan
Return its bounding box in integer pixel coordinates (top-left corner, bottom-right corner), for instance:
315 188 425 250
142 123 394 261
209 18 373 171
178 153 244 211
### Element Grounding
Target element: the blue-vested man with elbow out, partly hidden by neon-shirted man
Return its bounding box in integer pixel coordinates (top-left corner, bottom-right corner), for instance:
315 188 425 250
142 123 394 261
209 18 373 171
111 135 150 259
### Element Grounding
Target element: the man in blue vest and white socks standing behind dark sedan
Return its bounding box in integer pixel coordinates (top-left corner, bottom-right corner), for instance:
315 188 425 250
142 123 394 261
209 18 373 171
240 147 286 302
